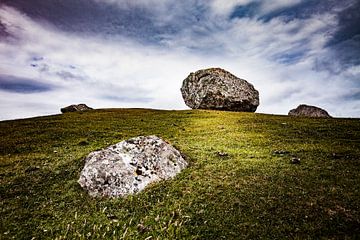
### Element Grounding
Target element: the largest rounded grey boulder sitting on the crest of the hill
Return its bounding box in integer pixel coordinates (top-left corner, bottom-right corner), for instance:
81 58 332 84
181 68 259 112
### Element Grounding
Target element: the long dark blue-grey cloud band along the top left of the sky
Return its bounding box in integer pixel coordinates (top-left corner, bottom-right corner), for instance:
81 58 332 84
4 0 172 41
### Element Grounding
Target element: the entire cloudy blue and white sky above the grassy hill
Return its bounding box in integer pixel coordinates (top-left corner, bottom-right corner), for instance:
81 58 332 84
0 0 360 120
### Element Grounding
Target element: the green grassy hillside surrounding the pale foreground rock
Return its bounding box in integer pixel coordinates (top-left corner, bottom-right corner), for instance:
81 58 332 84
0 109 360 239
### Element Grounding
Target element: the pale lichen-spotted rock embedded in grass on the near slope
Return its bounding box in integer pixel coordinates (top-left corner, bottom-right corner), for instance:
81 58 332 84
78 136 187 197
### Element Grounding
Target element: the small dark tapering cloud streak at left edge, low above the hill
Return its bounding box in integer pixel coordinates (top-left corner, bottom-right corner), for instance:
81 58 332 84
0 74 53 93
